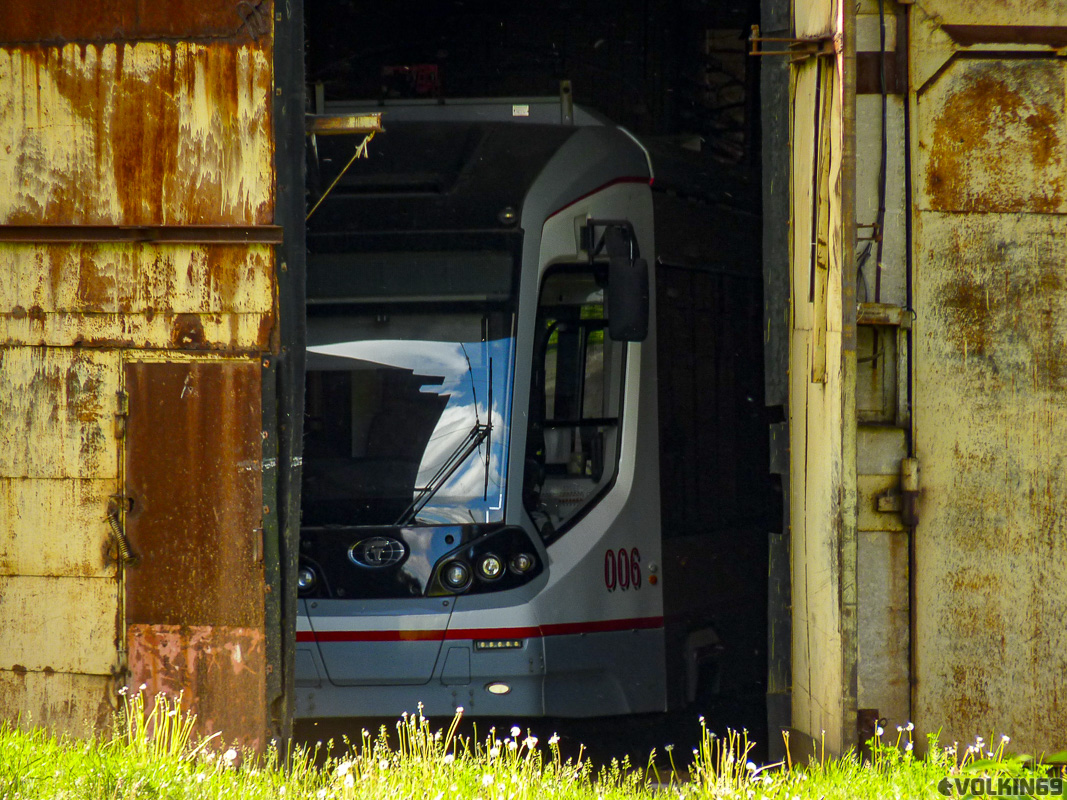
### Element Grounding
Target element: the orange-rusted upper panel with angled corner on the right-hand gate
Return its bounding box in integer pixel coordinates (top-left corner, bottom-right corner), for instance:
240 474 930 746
923 61 1067 212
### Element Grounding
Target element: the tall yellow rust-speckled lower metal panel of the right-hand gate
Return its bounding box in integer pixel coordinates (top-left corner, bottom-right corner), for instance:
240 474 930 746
915 206 1067 752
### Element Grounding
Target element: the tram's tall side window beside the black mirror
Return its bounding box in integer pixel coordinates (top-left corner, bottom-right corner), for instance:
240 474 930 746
524 268 625 540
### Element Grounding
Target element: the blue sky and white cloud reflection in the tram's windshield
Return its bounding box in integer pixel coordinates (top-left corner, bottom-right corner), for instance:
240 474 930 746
307 339 513 524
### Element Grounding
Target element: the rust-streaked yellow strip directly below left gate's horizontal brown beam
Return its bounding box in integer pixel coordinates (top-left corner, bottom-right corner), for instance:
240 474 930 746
0 243 275 352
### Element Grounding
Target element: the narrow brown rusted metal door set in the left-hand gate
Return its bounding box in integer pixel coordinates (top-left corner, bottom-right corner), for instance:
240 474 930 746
125 361 267 743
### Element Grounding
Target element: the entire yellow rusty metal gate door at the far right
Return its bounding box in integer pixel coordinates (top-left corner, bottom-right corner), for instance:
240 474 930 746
909 0 1067 753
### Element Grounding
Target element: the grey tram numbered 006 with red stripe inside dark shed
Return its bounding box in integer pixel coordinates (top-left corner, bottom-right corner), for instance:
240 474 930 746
296 100 767 718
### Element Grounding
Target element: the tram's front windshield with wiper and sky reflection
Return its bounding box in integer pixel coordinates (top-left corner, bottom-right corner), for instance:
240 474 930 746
301 310 514 526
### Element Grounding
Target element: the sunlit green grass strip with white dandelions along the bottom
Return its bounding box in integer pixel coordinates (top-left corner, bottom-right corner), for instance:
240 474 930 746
0 693 1062 800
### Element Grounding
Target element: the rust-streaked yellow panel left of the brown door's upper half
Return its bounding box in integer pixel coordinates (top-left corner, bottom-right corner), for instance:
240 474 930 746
0 348 120 479
